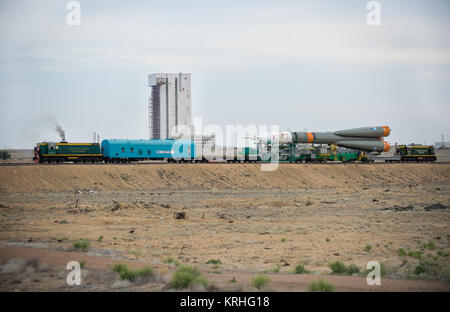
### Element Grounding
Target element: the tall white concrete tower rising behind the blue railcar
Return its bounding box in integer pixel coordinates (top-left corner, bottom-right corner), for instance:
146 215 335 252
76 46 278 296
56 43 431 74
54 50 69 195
148 73 192 139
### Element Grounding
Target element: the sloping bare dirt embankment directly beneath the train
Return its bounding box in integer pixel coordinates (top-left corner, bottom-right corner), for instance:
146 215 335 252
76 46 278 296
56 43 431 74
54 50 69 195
0 164 450 192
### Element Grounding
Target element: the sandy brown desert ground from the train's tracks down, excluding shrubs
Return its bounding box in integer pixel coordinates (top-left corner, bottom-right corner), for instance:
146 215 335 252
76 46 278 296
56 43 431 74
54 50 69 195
0 163 450 291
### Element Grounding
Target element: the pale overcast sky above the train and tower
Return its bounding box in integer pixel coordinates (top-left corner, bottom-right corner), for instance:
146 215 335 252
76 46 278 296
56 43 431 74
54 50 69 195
0 0 450 148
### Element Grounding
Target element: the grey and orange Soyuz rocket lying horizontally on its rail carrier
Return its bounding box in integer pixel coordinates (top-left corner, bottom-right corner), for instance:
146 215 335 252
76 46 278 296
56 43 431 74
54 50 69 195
272 126 391 152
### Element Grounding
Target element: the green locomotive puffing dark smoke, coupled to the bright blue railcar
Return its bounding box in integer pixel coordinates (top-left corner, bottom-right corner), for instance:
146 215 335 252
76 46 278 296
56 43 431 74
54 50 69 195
33 141 103 163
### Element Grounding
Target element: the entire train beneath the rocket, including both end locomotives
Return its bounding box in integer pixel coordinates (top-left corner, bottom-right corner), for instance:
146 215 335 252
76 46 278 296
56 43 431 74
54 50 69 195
33 139 436 163
